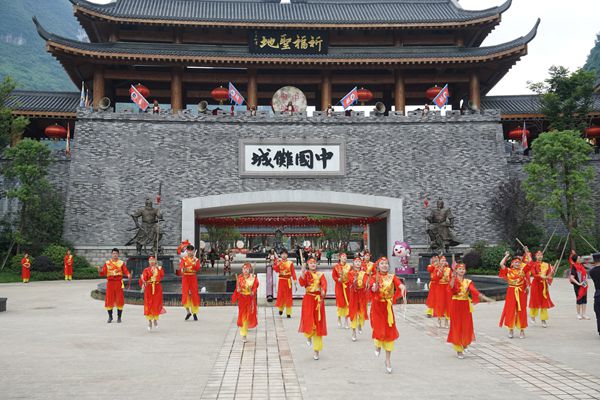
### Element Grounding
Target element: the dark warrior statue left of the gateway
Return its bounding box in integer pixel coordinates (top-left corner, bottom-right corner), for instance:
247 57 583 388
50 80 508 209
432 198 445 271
125 198 163 255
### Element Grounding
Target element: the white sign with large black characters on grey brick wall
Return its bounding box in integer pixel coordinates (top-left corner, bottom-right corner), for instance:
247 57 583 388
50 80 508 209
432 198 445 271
239 139 346 178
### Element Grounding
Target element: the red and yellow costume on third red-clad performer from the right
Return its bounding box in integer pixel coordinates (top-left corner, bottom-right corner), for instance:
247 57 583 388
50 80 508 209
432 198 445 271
447 278 479 353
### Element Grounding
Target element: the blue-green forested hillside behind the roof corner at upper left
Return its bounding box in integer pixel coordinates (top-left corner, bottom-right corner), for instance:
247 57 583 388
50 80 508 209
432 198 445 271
0 0 82 91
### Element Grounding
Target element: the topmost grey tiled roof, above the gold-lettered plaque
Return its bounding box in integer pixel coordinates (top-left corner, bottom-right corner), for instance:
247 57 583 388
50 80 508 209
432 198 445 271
70 0 512 25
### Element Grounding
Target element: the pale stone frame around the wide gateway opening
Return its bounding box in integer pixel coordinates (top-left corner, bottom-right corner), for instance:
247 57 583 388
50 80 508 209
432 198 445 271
181 190 404 257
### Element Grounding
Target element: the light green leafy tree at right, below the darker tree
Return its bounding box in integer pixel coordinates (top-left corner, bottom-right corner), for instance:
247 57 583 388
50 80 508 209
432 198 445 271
523 130 594 249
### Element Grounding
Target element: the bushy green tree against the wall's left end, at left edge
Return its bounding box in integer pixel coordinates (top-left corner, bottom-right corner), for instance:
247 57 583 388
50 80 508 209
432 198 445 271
2 139 64 254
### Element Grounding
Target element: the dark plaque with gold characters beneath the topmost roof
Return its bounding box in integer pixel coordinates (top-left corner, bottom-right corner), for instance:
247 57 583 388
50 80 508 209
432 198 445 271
248 29 329 54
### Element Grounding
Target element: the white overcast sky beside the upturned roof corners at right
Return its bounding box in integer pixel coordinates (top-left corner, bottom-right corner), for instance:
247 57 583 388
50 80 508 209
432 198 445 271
92 0 600 95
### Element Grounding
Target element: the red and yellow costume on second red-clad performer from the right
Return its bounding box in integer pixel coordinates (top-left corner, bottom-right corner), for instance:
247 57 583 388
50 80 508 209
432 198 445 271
498 261 529 330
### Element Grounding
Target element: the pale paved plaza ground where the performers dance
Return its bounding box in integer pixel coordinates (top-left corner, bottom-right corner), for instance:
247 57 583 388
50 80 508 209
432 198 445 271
0 279 600 400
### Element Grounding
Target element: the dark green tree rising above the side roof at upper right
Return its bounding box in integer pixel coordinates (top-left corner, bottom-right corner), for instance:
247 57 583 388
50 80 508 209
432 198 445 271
529 66 596 132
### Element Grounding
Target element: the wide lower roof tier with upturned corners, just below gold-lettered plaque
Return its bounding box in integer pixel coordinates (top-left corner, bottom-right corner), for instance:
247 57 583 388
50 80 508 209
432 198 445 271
34 17 540 63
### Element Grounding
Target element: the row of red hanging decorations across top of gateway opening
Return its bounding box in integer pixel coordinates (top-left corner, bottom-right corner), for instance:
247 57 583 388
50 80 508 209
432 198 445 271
196 216 385 227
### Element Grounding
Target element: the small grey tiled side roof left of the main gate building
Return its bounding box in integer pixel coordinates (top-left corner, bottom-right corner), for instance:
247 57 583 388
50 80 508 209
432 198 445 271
5 90 80 113
